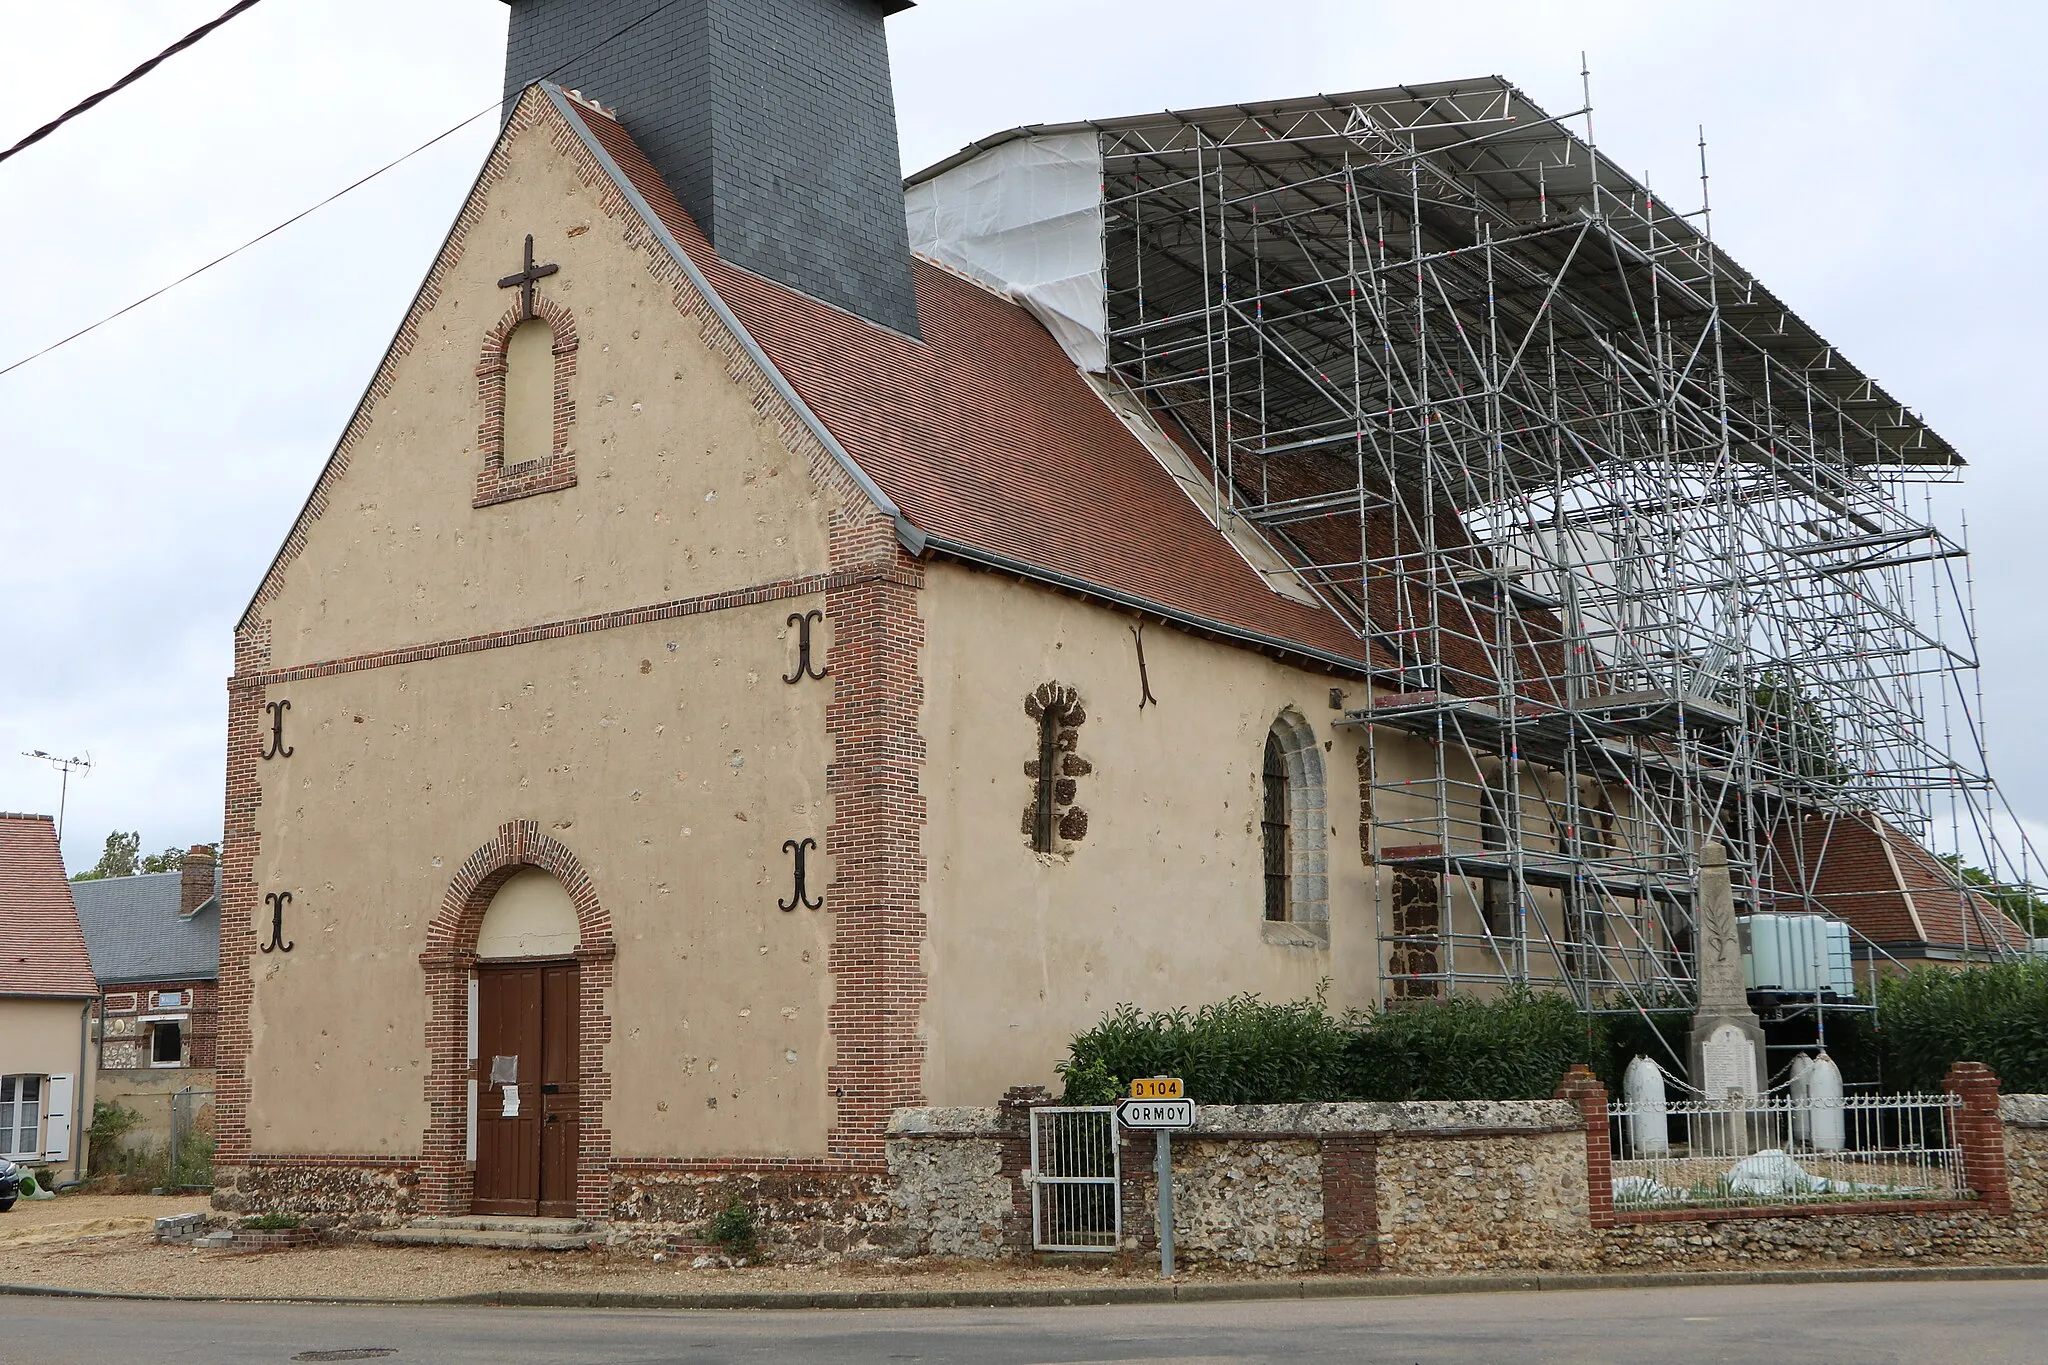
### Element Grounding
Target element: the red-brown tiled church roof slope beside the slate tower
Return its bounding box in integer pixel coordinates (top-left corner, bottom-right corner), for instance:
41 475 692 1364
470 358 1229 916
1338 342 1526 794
569 106 1391 667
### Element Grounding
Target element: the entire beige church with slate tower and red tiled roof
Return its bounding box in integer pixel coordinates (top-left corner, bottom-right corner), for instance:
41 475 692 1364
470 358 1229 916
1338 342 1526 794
217 0 2007 1220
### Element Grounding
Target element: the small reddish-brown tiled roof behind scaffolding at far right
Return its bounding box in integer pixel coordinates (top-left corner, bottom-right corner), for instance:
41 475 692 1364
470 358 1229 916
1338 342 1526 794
1776 812 2028 956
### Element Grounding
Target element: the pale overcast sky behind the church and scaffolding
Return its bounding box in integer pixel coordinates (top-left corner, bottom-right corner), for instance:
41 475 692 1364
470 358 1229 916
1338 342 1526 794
0 0 2048 870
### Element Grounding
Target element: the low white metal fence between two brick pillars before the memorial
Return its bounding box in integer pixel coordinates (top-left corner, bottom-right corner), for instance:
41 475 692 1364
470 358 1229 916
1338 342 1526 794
1608 1095 1970 1212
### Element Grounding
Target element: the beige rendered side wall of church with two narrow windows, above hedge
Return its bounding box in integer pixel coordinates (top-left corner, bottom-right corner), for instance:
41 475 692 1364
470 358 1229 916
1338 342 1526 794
920 563 1378 1105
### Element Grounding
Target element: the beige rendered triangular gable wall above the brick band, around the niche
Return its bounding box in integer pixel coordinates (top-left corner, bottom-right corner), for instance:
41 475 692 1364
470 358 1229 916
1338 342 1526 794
251 113 831 671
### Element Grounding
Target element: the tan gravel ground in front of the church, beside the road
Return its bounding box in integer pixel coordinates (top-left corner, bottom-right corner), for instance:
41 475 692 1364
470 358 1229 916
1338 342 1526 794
0 1195 1145 1300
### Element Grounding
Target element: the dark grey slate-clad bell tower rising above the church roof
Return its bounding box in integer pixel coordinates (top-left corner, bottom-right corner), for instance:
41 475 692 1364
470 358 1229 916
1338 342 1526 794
506 0 918 336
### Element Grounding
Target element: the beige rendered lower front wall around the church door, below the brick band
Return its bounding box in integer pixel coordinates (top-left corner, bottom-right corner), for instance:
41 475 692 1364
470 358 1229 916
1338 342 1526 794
250 604 829 1156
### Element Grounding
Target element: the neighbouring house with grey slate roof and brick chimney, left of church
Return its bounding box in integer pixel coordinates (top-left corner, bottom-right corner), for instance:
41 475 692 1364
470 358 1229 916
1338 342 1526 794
72 845 221 1144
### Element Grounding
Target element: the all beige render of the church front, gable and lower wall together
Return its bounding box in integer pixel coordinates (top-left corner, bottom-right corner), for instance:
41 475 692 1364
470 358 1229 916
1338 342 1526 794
235 100 868 1179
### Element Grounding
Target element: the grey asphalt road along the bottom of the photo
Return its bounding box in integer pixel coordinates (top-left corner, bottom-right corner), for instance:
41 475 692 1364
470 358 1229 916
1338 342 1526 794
0 1281 2048 1365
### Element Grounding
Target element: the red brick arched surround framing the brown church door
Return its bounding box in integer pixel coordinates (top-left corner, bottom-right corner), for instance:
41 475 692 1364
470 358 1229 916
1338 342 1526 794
420 821 616 1218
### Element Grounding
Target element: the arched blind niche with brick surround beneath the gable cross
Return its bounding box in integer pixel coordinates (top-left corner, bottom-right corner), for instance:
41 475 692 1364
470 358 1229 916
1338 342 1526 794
473 293 578 508
